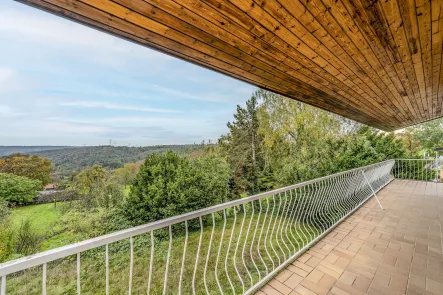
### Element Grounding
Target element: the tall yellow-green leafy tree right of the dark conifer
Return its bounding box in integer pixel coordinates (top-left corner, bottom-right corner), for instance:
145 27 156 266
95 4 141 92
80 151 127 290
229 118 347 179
256 90 344 186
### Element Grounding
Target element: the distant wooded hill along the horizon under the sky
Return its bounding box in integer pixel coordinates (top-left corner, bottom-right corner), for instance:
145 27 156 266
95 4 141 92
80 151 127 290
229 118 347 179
0 145 201 175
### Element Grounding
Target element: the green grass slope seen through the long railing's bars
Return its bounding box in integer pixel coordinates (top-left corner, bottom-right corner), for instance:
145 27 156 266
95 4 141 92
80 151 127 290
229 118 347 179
7 206 319 294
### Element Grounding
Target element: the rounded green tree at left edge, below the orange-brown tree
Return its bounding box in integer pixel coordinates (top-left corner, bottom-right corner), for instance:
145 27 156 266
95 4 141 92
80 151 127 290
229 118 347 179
0 173 42 205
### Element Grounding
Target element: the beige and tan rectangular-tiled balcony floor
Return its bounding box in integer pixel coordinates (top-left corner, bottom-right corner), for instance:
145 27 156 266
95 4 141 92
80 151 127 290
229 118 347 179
257 180 443 295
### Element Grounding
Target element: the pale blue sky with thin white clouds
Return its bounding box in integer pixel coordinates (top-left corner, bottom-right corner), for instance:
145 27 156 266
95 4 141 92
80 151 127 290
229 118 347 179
0 1 254 145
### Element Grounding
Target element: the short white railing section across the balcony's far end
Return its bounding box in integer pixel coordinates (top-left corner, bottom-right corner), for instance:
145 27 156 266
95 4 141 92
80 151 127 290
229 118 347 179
392 159 443 181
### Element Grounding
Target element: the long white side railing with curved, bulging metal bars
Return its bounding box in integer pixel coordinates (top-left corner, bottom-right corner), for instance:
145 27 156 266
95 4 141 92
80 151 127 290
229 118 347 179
0 160 395 295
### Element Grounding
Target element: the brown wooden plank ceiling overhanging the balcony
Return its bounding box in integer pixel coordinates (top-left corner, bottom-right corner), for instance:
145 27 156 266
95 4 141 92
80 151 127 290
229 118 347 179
19 0 443 131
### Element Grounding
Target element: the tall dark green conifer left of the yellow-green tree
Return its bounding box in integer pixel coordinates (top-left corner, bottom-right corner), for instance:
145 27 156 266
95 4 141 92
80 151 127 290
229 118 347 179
219 96 264 194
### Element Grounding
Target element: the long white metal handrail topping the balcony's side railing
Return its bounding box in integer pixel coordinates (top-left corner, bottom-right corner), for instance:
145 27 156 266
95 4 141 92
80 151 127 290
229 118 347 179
0 160 395 277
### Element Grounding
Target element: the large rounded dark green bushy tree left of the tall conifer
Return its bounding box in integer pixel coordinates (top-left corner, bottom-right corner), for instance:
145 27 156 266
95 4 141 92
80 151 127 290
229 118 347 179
123 151 229 224
